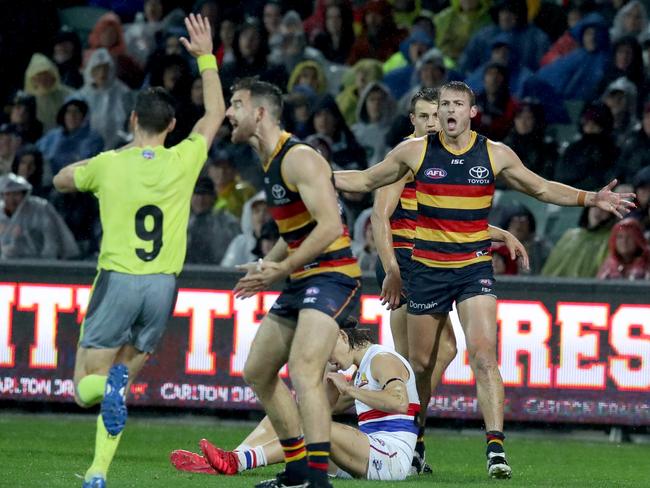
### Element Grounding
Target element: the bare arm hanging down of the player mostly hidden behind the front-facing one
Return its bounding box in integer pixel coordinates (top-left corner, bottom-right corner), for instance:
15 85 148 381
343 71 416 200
370 174 410 309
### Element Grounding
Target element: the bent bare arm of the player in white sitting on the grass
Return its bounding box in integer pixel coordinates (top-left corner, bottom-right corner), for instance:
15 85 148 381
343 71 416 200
327 353 409 414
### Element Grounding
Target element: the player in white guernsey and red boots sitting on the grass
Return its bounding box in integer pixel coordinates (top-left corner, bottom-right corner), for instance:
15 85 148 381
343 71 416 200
171 329 420 481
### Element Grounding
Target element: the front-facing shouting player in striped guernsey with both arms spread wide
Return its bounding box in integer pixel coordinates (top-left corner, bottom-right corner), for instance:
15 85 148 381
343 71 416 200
335 81 635 478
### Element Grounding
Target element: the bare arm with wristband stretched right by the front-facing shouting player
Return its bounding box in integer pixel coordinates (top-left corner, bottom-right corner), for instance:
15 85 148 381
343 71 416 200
488 141 636 218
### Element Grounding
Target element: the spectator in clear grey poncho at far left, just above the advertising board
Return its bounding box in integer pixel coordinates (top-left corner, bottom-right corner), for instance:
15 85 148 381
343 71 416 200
0 173 79 259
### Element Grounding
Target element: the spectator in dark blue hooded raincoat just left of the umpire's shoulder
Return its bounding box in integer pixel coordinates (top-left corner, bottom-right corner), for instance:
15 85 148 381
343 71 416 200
36 99 104 174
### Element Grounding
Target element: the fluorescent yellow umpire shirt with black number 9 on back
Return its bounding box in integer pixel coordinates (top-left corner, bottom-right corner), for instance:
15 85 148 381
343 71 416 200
74 133 207 275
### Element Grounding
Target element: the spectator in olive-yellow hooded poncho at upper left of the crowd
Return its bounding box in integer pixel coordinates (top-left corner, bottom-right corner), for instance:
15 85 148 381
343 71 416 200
25 53 72 130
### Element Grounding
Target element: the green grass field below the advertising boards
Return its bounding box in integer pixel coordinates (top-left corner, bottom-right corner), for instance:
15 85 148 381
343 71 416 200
0 414 650 488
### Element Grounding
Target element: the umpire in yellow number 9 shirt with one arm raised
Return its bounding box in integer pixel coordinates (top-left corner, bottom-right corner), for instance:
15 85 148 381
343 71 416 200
54 15 225 488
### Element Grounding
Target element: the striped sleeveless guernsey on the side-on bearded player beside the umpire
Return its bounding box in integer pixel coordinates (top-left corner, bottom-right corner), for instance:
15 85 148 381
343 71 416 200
263 132 361 280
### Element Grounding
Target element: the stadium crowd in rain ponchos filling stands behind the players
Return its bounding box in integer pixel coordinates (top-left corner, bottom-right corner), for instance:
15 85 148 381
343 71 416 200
0 0 650 280
